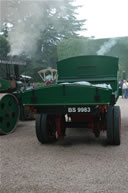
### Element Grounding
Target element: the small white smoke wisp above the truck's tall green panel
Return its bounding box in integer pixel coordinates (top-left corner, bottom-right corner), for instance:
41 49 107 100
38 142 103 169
96 38 119 55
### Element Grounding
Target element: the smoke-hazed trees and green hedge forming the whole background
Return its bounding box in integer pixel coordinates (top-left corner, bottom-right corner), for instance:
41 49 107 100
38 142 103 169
0 0 128 81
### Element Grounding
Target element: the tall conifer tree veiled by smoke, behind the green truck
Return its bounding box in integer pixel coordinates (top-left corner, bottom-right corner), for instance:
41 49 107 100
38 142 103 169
0 0 85 80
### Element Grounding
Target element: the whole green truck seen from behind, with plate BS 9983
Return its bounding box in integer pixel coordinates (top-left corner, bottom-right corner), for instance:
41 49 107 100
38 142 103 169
20 55 121 145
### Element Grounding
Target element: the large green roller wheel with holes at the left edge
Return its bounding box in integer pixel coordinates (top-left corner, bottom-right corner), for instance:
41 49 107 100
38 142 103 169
0 94 19 134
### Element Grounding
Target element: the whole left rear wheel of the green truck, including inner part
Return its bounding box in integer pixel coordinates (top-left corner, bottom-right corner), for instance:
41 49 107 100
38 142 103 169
36 114 56 143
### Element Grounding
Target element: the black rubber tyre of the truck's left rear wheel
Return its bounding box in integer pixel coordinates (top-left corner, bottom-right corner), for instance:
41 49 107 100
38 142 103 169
36 114 56 144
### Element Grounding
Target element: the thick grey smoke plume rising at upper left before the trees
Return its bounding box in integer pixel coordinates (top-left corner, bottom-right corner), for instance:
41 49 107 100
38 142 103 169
9 1 43 55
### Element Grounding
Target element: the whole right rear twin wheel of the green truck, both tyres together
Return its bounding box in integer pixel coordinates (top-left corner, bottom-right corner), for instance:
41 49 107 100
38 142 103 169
107 106 121 145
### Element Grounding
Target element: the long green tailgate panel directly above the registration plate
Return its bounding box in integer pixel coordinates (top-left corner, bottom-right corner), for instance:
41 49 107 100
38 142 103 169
22 85 112 106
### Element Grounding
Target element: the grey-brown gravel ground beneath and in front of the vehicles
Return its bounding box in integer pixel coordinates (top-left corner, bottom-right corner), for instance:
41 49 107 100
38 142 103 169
0 98 128 193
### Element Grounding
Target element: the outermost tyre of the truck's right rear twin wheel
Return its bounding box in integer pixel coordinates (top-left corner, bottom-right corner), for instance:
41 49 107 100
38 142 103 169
113 106 121 145
